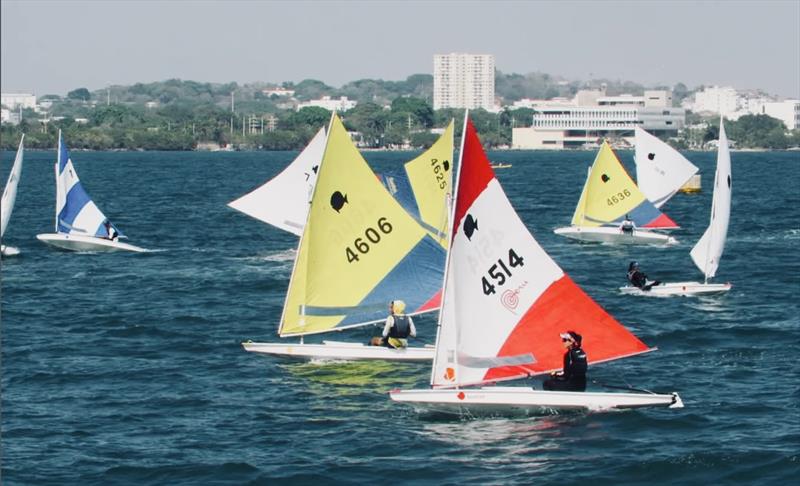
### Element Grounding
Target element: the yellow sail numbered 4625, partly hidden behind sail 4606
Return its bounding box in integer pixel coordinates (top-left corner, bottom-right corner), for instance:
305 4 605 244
405 120 454 248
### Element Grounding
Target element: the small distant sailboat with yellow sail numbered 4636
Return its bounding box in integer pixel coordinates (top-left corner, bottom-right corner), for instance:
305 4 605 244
555 141 678 245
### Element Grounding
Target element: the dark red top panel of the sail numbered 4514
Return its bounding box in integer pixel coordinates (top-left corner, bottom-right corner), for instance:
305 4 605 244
451 119 494 238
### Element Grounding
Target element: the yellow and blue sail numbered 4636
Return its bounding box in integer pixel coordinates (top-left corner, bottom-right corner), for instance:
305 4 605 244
572 142 663 227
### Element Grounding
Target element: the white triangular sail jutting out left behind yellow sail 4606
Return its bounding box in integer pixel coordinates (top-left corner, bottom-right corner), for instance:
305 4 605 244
228 127 326 236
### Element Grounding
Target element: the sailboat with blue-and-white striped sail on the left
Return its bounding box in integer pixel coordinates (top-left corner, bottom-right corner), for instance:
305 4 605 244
36 130 146 252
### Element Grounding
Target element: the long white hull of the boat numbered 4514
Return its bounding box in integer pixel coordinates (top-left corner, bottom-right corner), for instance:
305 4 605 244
389 387 683 415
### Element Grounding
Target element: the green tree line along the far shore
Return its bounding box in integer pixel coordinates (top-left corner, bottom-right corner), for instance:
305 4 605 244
0 78 800 150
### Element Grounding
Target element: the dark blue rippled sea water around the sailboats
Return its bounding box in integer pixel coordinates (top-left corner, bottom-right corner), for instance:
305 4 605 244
0 146 800 485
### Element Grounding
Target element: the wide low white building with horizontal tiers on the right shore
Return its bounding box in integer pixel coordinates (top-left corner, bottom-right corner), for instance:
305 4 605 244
511 90 686 149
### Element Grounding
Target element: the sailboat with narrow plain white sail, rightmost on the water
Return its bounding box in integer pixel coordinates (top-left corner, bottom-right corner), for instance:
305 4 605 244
620 120 732 296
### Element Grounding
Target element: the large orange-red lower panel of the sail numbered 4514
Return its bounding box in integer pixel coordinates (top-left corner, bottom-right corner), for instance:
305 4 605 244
484 274 649 381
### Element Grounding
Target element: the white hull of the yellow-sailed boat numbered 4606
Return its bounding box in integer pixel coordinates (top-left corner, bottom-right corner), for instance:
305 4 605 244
242 341 435 361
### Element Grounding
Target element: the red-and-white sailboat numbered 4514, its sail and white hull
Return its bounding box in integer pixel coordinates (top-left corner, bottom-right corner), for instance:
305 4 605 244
390 116 682 414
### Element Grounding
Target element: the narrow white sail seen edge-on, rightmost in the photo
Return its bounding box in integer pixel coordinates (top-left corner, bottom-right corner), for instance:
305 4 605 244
691 120 731 281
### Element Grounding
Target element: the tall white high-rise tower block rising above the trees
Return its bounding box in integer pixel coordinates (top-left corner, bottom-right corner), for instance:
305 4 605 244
433 53 497 111
